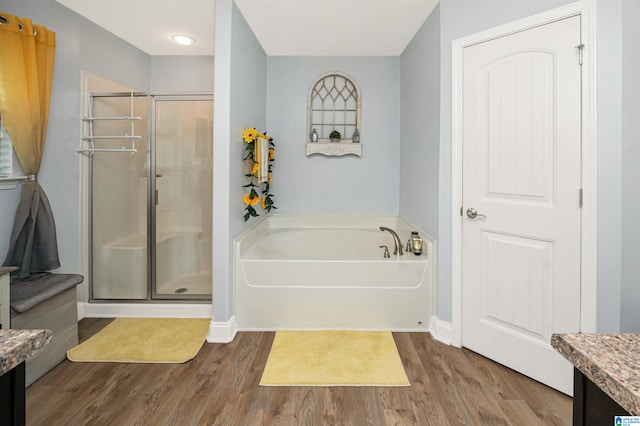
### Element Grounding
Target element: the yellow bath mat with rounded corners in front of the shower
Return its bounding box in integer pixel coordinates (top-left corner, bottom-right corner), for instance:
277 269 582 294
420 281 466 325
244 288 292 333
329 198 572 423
67 318 211 363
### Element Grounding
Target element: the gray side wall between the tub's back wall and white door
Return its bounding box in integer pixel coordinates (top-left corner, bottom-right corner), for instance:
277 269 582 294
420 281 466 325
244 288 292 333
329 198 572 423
400 5 440 240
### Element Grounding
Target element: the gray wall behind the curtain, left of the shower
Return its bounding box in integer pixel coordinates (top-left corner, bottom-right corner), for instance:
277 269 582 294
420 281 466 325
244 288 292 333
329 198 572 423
0 0 150 280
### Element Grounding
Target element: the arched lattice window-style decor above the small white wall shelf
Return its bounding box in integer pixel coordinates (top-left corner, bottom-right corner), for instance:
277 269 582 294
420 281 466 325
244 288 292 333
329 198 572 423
307 71 360 143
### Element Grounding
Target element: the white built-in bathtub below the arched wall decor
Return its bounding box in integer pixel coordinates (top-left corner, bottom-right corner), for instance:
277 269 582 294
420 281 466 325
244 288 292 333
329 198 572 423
234 215 434 331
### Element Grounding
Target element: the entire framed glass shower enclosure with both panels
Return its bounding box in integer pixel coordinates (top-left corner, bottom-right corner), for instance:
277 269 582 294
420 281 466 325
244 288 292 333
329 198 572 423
80 92 213 302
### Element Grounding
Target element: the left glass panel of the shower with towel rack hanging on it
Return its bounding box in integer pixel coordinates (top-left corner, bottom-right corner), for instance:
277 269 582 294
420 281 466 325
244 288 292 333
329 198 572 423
90 93 149 301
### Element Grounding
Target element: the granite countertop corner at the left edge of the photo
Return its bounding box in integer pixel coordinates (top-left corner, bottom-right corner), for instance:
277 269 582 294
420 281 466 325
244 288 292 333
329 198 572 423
0 329 52 375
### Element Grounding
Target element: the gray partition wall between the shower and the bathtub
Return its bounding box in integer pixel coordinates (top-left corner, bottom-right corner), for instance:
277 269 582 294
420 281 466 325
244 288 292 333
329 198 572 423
213 0 267 322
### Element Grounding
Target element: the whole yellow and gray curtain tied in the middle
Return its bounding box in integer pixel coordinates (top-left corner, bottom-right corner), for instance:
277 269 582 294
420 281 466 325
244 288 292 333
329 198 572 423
0 11 60 278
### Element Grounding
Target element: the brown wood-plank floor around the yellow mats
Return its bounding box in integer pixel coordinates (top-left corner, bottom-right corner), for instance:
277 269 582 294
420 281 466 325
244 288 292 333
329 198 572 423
27 319 572 426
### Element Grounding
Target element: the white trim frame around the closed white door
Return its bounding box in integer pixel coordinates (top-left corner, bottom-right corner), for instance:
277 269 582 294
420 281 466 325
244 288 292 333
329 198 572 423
451 0 598 347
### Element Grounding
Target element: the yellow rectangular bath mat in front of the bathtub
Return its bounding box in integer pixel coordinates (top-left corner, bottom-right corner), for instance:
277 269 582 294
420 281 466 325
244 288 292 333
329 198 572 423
260 330 410 386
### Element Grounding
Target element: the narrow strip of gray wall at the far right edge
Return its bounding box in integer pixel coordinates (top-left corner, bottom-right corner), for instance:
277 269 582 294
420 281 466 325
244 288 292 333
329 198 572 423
620 0 640 333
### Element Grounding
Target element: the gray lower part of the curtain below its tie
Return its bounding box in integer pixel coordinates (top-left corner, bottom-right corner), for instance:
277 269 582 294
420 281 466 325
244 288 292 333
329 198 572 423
4 181 60 278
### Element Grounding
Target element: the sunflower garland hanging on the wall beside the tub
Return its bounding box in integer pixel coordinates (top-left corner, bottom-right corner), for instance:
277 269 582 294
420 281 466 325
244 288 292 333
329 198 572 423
242 127 276 222
